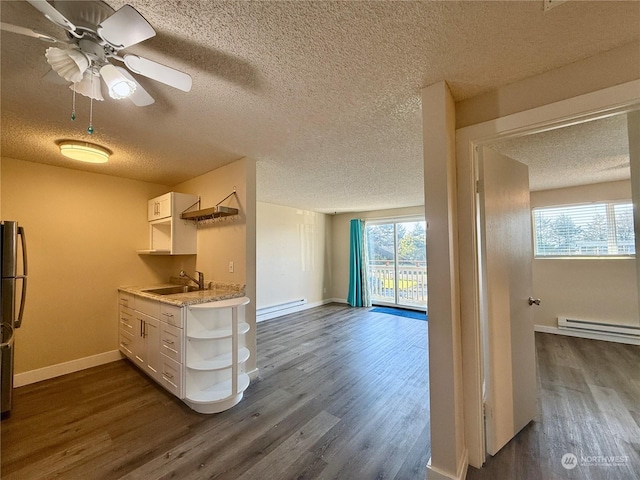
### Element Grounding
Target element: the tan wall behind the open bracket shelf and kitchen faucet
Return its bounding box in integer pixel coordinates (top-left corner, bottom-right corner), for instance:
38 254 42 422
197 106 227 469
172 158 256 370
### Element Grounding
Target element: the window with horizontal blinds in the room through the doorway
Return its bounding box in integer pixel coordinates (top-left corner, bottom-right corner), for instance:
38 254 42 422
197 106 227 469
533 202 636 257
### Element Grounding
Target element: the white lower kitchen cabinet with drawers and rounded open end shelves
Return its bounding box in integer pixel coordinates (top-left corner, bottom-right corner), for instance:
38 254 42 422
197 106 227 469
119 292 250 413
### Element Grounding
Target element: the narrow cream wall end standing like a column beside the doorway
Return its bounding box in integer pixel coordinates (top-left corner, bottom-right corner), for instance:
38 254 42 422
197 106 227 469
422 82 467 480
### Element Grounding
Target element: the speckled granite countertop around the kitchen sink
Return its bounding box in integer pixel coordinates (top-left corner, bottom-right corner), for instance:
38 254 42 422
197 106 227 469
118 279 245 307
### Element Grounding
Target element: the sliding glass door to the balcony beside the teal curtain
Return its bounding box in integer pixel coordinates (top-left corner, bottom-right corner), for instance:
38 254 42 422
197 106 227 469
366 219 427 309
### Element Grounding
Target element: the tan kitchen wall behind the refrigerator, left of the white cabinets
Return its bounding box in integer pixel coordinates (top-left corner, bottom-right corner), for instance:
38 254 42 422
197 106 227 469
2 158 173 373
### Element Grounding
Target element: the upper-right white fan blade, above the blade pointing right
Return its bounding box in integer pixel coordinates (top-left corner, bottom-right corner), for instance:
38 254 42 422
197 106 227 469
98 5 156 50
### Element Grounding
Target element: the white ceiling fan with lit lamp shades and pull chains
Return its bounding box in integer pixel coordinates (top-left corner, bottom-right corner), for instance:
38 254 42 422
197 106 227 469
0 0 192 119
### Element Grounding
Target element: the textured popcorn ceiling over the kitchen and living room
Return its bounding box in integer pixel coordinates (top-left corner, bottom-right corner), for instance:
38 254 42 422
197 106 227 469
0 0 640 212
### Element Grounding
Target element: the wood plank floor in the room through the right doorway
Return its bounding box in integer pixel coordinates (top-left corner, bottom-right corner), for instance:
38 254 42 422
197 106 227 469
467 333 640 480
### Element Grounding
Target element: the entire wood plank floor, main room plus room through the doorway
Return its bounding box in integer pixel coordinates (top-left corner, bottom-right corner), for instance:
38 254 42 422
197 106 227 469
0 305 640 480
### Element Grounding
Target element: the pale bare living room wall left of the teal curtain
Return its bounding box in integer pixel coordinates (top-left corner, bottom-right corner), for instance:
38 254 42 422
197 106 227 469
256 202 331 308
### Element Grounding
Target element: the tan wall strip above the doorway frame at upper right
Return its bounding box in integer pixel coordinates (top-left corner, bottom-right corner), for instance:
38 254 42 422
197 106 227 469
456 42 640 128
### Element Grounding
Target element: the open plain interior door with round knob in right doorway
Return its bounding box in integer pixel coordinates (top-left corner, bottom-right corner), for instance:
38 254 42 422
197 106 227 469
478 148 537 455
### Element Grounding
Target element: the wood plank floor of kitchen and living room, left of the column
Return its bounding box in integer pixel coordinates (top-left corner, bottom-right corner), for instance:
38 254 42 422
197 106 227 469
0 305 430 480
